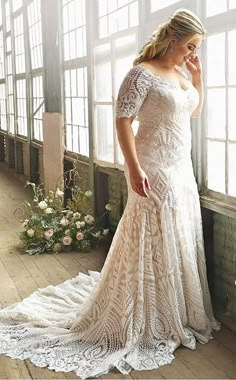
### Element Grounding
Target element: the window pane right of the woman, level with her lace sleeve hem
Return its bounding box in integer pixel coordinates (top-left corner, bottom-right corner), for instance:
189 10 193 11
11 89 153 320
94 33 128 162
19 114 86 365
207 89 226 138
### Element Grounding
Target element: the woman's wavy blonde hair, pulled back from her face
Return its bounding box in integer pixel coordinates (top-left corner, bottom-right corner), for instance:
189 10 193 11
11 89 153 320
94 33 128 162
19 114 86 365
134 9 206 65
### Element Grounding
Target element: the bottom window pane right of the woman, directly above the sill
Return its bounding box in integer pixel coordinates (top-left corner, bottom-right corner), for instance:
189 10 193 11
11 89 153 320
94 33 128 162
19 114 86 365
207 141 225 193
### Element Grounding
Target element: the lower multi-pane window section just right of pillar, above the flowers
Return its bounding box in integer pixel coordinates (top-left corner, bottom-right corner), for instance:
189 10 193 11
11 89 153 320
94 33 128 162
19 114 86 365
65 67 89 156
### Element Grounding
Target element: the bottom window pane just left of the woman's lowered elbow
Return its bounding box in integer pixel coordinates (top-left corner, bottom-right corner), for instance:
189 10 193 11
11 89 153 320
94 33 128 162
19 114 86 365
96 106 114 162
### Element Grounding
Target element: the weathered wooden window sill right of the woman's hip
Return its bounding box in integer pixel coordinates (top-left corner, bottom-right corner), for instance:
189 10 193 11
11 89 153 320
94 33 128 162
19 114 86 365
200 195 236 219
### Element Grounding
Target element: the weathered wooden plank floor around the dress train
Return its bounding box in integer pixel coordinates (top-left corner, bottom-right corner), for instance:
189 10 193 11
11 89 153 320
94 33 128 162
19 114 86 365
0 165 236 379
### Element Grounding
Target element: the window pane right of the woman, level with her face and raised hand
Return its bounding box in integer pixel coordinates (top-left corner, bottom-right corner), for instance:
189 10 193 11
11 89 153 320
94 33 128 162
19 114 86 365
207 33 225 86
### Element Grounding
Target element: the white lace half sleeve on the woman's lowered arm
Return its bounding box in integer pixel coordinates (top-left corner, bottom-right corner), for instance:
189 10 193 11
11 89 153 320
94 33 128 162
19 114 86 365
116 66 151 118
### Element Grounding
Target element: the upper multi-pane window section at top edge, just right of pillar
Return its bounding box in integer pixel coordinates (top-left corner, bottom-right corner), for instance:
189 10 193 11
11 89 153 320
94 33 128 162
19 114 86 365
63 0 87 61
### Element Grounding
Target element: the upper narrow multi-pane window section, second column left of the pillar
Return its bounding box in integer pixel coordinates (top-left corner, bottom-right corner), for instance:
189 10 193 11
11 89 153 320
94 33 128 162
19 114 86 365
14 14 25 74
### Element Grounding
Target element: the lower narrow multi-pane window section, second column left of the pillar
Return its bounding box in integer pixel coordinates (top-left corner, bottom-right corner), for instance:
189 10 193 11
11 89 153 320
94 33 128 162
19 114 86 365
16 79 28 136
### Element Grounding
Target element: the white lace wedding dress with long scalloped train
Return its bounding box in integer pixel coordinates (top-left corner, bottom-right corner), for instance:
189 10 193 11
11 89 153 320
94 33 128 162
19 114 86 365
0 66 219 379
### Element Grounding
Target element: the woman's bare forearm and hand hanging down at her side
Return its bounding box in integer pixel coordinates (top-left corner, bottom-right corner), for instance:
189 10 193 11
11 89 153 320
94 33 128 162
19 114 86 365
116 117 151 197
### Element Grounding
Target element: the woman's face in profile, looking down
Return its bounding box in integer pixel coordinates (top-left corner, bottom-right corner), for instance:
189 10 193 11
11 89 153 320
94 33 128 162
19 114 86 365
172 36 203 66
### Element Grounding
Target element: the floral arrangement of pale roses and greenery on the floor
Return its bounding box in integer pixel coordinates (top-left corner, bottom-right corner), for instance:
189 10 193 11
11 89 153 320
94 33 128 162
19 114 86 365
17 175 112 255
